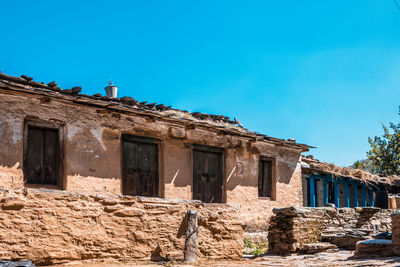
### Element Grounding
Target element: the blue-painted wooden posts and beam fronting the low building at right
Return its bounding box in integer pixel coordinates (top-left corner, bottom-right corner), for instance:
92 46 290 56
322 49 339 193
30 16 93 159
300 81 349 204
306 174 375 208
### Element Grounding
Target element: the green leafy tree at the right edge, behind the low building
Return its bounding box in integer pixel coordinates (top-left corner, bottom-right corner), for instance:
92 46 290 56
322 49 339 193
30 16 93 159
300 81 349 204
367 123 400 176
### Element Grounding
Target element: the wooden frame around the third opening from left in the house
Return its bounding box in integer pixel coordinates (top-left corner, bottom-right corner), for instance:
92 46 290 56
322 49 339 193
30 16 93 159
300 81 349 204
189 144 227 204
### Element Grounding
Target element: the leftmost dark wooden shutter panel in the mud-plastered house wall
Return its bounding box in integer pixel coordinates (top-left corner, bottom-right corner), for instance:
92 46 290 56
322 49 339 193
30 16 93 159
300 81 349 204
24 126 60 185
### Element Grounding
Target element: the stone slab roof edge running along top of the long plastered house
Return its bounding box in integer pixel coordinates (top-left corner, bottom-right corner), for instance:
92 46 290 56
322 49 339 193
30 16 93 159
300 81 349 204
0 72 313 151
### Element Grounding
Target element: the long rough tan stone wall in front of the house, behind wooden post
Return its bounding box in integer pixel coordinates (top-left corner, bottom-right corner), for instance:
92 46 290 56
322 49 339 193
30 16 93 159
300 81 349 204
0 189 244 265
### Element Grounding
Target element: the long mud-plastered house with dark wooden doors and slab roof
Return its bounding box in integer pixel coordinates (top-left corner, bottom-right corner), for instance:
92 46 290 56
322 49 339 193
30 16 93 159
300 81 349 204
0 73 310 227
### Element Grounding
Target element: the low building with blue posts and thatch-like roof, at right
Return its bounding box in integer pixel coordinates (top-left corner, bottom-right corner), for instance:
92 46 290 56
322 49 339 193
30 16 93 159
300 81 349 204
302 158 392 209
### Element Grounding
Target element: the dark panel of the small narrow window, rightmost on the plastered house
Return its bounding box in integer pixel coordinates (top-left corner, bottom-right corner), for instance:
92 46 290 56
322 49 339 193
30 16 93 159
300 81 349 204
258 159 274 198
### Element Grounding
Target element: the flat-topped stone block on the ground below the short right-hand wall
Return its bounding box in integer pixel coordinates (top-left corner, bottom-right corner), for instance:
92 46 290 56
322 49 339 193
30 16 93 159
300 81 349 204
354 239 394 258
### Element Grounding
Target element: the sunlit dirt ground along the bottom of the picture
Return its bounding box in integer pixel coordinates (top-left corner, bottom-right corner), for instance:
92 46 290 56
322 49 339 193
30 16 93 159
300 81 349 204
52 250 400 267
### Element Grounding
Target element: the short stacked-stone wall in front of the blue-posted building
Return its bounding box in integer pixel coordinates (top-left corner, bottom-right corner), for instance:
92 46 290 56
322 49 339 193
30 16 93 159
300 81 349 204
268 207 390 254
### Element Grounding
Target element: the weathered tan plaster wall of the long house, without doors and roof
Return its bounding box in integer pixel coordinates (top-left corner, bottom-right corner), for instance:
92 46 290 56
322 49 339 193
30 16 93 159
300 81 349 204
0 93 303 231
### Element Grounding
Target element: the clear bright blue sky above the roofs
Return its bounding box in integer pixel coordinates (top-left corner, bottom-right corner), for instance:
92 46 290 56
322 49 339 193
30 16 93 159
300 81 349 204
0 0 400 165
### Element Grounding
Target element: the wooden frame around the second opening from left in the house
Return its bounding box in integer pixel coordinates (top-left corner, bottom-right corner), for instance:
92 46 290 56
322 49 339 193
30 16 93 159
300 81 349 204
120 133 164 197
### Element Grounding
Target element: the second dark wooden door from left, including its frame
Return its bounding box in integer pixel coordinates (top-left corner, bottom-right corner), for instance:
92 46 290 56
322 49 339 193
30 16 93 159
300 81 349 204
122 135 158 197
